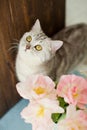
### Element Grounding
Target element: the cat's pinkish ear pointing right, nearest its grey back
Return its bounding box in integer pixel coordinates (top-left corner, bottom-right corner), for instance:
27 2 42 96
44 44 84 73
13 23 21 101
51 40 63 52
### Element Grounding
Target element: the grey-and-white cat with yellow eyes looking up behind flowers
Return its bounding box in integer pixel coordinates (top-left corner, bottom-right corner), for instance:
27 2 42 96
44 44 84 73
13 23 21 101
16 19 87 81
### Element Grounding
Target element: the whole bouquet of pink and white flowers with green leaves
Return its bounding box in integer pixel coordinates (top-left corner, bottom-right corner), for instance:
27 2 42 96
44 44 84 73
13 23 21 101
16 74 87 130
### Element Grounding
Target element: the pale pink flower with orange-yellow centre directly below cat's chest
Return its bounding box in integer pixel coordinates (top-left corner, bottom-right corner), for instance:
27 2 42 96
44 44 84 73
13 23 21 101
16 75 57 100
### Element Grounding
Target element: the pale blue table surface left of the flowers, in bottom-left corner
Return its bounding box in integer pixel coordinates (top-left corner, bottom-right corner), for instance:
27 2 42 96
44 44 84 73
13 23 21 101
0 99 32 130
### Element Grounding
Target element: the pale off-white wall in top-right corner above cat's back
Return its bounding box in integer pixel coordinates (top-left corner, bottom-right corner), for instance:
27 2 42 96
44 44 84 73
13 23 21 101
66 0 87 26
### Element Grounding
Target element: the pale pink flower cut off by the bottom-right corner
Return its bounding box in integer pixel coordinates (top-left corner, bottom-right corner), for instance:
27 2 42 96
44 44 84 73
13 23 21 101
57 105 87 130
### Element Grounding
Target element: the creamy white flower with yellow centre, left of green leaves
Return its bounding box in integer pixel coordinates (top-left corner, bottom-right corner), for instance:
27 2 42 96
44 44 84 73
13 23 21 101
21 98 64 130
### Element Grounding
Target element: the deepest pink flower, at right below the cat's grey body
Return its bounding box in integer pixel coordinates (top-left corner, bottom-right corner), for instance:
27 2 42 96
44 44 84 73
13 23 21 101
57 75 87 108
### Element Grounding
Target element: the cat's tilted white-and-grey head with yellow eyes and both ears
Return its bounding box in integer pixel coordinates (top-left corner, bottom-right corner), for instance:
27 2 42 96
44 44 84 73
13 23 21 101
18 19 63 62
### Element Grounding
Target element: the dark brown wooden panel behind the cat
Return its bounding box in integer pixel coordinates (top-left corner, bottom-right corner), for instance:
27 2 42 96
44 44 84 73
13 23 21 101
0 0 65 116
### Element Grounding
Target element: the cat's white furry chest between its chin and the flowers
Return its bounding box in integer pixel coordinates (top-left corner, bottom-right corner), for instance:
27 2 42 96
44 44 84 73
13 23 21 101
16 55 48 81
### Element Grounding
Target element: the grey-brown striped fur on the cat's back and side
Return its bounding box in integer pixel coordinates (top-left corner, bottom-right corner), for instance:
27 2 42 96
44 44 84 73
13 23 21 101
51 24 87 79
